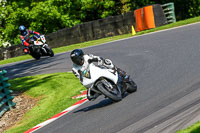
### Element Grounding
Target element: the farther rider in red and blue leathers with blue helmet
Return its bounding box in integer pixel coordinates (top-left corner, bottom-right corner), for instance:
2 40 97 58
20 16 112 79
19 25 40 53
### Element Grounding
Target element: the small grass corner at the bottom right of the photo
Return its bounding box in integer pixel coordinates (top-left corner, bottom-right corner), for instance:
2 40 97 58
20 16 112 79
177 121 200 133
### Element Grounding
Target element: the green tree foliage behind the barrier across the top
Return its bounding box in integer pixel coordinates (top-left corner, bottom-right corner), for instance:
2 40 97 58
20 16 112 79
0 0 200 46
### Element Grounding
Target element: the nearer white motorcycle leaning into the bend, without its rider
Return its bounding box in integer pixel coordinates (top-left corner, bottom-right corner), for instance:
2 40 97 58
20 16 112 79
81 63 137 102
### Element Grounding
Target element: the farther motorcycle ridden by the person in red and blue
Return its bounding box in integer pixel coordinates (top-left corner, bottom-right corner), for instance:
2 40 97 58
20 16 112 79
29 35 54 60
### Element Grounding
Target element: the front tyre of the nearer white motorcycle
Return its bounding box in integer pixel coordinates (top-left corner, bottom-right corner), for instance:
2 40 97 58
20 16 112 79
97 82 122 102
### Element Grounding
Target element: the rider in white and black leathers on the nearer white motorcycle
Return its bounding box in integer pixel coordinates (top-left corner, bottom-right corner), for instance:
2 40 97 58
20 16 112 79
70 49 129 100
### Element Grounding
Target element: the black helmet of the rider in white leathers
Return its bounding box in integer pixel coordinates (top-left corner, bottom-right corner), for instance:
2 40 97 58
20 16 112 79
70 49 84 66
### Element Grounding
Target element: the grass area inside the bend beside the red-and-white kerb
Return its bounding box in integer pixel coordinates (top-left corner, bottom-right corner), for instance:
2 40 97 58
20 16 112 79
6 73 84 133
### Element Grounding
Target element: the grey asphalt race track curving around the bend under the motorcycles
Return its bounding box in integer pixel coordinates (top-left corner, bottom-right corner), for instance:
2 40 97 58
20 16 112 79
0 23 200 133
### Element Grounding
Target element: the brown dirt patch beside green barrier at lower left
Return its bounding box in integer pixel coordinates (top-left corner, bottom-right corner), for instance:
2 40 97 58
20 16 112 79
0 93 39 133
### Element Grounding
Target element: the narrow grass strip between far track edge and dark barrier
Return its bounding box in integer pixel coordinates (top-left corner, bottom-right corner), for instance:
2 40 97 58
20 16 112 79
0 17 200 65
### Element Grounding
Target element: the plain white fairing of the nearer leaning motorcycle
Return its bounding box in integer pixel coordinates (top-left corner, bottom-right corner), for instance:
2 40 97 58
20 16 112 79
82 63 118 88
